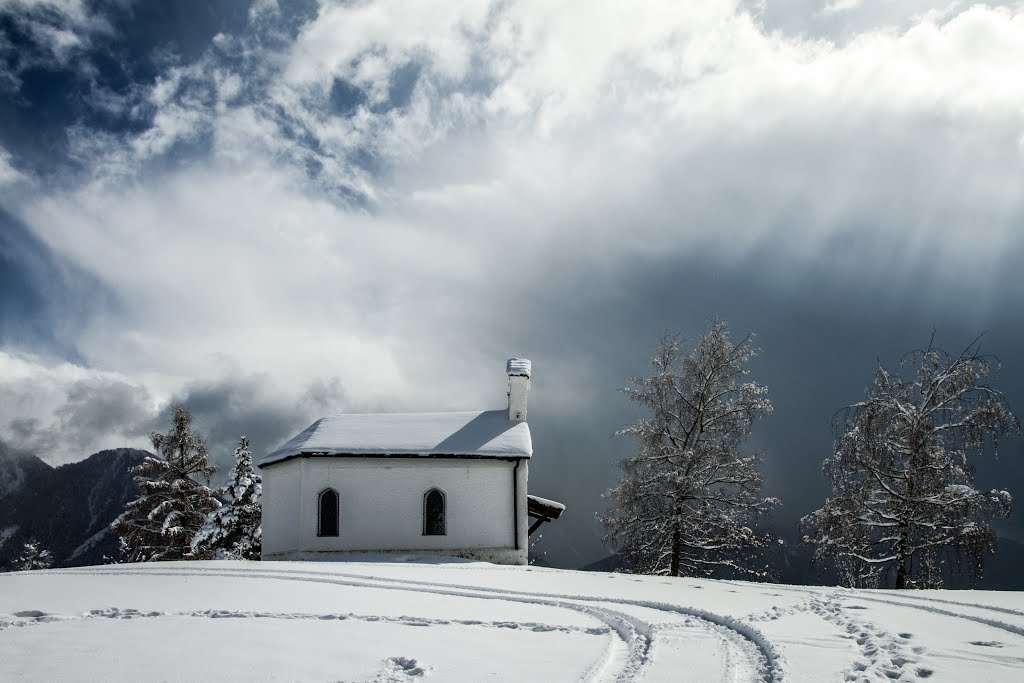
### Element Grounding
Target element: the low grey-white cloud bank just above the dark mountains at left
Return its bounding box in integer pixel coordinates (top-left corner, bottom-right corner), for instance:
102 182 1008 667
0 351 350 467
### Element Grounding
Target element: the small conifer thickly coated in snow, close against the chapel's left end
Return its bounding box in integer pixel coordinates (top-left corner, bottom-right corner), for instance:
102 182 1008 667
191 436 263 560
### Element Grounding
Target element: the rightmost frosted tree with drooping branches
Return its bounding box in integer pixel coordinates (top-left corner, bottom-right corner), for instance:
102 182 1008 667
801 334 1020 588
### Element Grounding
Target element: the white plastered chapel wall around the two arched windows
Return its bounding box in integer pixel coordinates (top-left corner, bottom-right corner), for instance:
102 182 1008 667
263 457 528 563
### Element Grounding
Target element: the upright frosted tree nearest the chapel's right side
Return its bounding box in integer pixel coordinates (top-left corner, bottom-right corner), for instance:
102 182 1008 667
601 319 778 575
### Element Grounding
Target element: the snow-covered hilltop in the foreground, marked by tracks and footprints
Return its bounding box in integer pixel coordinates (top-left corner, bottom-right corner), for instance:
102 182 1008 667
0 558 1024 683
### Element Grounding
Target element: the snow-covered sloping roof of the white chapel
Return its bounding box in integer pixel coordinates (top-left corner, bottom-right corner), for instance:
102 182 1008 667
259 411 534 467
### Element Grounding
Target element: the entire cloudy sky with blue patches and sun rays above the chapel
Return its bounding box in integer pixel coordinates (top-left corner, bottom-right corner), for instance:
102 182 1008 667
0 0 1024 561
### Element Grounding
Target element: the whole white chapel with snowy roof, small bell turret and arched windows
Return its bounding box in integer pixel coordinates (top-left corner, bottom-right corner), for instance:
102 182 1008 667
258 358 564 564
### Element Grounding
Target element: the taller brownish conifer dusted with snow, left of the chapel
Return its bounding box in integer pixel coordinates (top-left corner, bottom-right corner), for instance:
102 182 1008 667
111 404 220 562
